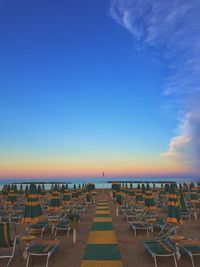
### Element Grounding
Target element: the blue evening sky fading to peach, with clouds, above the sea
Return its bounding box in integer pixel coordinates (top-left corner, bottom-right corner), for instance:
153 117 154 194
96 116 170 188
0 0 200 178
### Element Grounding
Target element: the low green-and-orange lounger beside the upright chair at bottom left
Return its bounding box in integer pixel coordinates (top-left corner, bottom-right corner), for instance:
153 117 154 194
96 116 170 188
26 240 60 267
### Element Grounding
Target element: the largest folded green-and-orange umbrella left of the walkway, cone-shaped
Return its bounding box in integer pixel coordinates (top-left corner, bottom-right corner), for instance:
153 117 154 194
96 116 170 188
21 184 44 223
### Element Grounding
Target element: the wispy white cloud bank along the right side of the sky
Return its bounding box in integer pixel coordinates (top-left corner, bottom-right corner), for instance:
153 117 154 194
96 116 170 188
110 0 200 172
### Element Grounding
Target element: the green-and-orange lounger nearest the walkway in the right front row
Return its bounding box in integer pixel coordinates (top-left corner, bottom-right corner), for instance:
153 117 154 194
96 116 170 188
143 240 177 267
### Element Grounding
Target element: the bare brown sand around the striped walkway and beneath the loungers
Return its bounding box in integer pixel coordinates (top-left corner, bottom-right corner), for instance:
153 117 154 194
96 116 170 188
0 190 200 267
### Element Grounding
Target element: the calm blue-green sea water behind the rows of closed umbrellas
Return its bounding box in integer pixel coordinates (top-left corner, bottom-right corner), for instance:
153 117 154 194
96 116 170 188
0 177 200 190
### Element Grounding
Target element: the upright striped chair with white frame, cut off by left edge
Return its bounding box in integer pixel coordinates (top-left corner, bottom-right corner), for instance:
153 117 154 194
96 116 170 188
0 222 21 266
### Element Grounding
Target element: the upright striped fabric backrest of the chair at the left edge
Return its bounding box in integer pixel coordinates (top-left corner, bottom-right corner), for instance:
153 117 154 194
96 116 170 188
0 222 13 248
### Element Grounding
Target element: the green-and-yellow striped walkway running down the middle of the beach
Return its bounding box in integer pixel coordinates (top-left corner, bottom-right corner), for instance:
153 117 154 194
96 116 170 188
81 200 123 267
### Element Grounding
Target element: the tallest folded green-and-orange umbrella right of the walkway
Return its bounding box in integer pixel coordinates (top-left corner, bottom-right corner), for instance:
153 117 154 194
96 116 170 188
167 184 181 224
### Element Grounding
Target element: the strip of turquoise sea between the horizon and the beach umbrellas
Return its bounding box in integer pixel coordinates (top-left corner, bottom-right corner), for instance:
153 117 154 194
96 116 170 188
0 177 200 190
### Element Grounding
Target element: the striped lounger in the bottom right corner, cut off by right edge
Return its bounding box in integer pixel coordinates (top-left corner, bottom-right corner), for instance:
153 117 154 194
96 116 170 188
179 239 200 267
